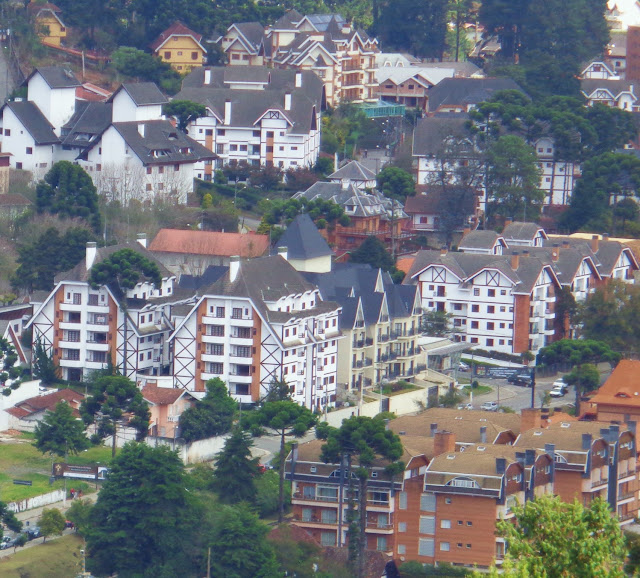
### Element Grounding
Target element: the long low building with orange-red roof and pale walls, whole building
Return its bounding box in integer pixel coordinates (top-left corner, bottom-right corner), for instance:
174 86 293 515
149 229 269 277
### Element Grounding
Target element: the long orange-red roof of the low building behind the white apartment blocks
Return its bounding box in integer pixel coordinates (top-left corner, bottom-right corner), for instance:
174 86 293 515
149 229 269 259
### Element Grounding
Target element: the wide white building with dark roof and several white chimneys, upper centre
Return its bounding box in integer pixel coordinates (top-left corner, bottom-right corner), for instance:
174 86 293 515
176 66 325 173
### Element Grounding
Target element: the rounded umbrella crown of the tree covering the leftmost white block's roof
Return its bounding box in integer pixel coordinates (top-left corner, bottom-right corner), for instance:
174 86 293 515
89 249 162 297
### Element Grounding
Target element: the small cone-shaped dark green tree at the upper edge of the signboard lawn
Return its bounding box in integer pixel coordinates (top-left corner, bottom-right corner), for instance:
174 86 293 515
33 401 91 460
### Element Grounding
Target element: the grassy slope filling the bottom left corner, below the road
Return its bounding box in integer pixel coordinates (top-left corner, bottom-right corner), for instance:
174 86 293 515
0 534 84 578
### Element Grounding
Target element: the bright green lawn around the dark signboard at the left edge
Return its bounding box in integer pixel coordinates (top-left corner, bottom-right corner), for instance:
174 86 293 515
0 436 111 498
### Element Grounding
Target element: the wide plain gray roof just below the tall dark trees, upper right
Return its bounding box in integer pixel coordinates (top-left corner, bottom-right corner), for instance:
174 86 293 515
427 78 524 112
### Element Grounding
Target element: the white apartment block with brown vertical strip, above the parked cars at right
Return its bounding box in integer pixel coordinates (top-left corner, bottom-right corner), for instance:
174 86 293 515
404 250 560 353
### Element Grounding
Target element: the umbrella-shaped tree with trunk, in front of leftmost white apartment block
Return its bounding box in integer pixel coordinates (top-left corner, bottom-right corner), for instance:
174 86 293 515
89 249 162 377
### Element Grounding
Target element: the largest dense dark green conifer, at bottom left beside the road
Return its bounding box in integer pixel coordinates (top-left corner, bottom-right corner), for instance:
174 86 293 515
85 442 204 578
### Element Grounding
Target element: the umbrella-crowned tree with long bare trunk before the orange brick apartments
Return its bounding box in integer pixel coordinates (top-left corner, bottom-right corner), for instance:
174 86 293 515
321 416 404 578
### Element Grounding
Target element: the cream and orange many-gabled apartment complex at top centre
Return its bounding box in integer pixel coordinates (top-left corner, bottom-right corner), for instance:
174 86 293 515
221 10 379 106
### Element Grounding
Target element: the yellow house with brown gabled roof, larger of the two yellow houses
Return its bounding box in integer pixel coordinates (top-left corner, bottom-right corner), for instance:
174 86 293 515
151 21 207 73
